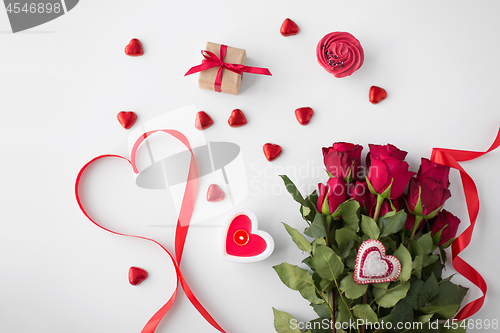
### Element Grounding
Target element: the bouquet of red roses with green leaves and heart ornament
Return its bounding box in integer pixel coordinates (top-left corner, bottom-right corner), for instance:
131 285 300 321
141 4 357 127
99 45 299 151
274 143 467 333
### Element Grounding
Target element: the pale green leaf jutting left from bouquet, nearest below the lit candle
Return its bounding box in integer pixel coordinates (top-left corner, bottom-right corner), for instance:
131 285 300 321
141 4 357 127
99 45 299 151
273 262 323 304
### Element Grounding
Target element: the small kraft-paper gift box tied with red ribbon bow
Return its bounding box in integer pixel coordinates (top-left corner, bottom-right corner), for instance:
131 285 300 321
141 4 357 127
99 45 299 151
184 42 271 95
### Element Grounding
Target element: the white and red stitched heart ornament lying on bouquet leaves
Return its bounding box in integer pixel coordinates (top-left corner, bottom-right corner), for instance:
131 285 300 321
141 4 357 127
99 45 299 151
354 239 401 284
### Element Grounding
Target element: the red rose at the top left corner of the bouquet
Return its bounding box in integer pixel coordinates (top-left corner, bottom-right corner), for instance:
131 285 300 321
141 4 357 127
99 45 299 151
323 142 363 182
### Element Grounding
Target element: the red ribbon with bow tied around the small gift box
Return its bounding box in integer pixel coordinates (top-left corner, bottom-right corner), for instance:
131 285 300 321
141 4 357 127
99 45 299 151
184 45 272 92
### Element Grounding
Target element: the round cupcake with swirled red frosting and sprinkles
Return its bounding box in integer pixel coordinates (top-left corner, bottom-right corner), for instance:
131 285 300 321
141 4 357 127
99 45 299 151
316 31 365 78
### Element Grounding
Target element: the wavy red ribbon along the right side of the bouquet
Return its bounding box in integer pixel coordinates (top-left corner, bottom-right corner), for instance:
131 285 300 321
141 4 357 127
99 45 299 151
431 129 500 320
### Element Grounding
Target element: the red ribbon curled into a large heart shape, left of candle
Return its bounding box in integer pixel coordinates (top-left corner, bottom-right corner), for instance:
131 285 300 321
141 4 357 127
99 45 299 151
75 130 225 333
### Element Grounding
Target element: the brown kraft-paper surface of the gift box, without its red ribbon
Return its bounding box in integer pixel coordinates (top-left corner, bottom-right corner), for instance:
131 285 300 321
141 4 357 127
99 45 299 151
198 42 247 95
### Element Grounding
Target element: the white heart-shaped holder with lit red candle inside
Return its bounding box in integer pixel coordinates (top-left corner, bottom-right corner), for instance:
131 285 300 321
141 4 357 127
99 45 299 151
222 209 274 262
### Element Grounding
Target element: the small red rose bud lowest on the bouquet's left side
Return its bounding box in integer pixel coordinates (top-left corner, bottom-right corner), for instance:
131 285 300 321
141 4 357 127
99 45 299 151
316 177 348 215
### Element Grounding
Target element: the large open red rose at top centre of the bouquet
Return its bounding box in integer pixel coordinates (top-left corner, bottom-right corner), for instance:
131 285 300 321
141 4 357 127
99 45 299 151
368 144 415 199
